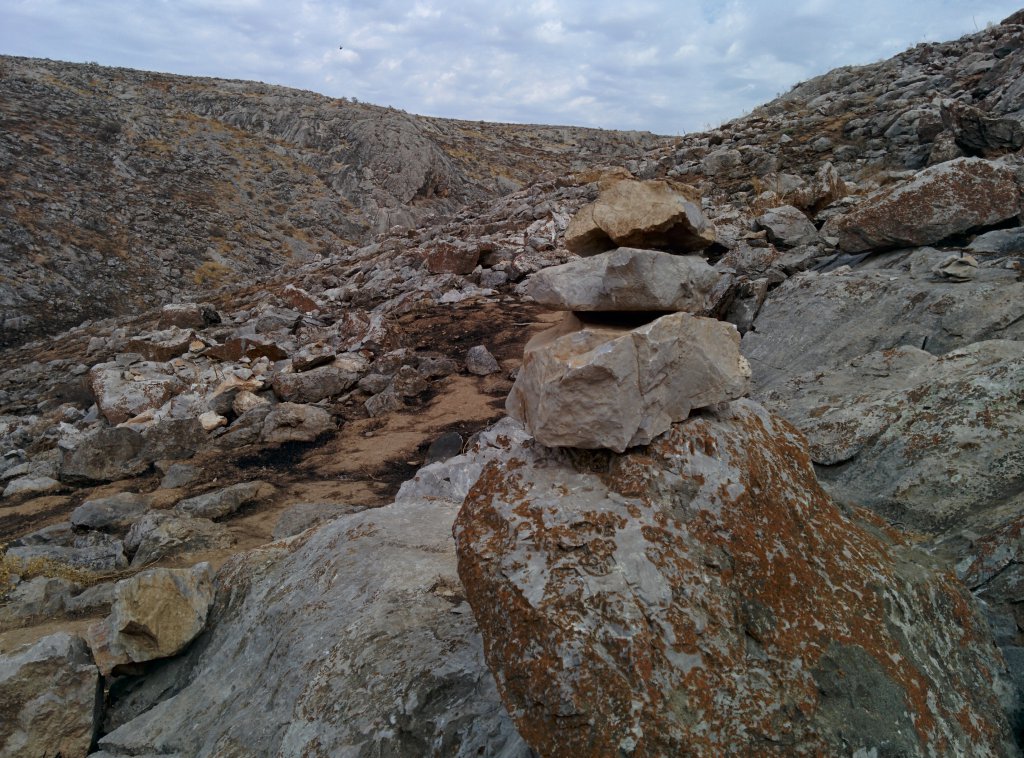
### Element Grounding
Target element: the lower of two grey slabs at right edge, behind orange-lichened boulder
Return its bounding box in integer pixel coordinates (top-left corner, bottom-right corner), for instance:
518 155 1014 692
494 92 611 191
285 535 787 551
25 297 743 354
763 340 1024 536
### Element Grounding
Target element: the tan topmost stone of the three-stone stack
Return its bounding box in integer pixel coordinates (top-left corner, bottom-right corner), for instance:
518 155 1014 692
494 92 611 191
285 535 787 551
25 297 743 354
565 179 715 255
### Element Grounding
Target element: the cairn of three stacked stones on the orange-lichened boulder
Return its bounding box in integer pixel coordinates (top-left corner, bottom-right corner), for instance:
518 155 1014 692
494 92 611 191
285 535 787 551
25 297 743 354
506 178 751 453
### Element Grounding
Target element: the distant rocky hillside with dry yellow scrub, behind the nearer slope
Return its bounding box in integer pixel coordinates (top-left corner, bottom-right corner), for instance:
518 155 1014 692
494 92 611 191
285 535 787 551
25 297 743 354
0 56 666 345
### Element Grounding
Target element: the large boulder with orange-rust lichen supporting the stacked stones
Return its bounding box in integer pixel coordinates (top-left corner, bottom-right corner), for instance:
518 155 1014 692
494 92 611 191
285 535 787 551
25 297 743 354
455 401 1014 756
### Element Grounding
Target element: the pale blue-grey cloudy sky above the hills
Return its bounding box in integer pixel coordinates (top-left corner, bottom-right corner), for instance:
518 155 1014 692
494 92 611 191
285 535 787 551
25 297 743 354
0 0 1024 134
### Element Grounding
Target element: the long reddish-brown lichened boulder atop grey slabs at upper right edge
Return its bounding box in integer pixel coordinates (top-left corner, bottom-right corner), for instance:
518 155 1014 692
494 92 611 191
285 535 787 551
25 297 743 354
837 158 1021 253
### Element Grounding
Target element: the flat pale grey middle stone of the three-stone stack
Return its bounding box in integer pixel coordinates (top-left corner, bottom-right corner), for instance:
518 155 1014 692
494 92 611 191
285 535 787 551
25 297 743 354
524 248 721 313
